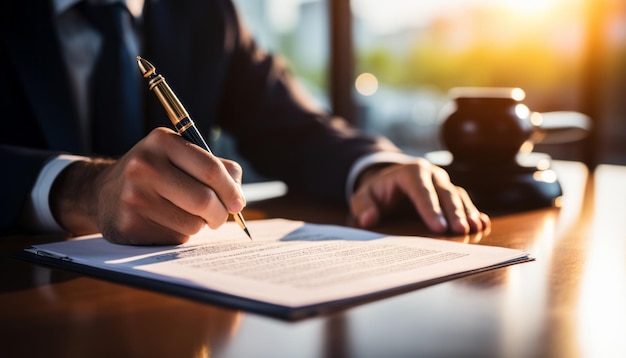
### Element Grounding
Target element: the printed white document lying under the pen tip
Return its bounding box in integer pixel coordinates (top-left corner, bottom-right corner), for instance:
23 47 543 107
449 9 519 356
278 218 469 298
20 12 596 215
19 219 532 318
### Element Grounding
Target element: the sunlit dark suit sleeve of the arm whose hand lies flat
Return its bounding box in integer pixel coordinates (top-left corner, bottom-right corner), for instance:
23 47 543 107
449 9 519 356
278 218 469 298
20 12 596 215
214 1 399 201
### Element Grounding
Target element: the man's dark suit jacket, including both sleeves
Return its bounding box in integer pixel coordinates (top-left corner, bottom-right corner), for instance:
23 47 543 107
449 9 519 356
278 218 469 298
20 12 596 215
0 0 397 232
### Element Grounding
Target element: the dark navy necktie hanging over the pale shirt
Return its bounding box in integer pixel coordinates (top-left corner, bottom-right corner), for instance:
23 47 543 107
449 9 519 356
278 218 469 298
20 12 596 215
78 1 143 156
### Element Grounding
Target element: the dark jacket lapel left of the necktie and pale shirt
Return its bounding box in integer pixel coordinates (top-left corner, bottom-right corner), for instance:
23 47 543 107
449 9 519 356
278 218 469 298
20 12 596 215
8 0 83 153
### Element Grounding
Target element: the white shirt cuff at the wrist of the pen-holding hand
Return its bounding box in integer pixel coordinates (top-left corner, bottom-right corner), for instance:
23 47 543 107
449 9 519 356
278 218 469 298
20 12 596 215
30 154 87 233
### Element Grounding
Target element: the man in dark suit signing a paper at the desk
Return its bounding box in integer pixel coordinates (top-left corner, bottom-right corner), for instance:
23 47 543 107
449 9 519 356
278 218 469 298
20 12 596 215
0 0 489 244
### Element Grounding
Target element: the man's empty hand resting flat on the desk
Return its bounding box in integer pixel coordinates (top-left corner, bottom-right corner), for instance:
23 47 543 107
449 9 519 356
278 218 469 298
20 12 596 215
350 158 491 234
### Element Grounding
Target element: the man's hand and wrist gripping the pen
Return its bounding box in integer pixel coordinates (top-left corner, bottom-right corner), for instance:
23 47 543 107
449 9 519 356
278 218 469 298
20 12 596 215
50 128 245 245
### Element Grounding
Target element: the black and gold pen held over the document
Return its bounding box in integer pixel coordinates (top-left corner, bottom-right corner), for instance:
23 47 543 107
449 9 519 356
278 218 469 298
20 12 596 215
137 56 252 240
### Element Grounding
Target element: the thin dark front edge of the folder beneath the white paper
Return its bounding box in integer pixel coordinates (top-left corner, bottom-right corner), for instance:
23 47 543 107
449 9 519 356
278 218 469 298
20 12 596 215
10 251 534 321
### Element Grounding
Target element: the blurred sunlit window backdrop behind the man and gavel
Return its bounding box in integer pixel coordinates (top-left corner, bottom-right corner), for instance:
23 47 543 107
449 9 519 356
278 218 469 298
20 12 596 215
216 0 626 181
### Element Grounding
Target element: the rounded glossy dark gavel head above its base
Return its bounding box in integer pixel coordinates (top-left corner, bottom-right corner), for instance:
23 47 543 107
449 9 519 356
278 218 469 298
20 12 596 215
440 87 534 165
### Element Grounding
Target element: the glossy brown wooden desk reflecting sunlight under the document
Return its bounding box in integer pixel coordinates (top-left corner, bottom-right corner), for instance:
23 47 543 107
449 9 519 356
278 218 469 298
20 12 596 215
0 162 626 357
